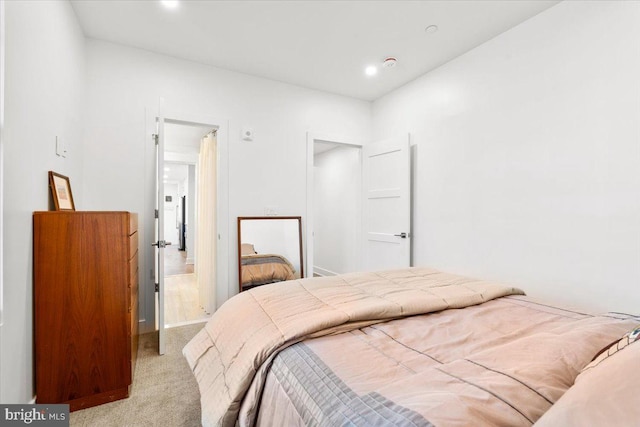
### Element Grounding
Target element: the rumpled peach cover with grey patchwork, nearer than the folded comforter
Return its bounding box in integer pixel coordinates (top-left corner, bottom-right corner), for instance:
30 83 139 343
254 295 640 427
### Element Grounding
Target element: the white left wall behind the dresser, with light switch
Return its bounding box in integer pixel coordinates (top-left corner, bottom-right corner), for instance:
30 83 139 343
0 1 86 403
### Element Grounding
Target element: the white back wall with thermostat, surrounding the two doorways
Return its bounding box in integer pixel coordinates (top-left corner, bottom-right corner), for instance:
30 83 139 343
83 40 371 332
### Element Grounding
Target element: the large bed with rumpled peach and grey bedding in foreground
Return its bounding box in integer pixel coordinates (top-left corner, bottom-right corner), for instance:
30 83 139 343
183 268 640 426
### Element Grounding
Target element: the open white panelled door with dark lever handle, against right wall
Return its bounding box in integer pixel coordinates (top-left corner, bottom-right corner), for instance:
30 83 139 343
363 135 411 271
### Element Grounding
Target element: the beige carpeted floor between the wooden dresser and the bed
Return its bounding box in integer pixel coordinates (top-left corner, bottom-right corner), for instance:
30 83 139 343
71 323 204 427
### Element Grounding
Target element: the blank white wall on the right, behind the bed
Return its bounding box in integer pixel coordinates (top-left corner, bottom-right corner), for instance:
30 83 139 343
373 1 640 313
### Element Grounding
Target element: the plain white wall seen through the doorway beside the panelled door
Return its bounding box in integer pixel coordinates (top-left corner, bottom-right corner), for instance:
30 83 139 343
313 146 362 275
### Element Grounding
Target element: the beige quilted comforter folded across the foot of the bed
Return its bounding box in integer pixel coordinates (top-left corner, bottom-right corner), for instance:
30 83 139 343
183 268 522 426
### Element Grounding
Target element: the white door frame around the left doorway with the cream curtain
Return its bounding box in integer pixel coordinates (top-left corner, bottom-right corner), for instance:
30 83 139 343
140 105 229 340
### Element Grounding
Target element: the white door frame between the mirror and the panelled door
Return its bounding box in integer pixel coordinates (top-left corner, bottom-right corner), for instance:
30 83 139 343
303 132 363 277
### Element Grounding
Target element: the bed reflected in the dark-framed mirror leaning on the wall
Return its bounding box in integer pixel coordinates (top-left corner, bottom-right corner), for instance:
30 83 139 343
240 243 296 290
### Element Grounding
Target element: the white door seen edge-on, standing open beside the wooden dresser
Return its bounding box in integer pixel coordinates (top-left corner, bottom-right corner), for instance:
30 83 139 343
152 113 171 354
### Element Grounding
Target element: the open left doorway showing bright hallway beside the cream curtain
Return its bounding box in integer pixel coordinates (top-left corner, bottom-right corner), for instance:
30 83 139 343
163 122 215 328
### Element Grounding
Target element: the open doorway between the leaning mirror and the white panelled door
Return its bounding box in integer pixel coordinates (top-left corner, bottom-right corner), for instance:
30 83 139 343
307 135 362 276
